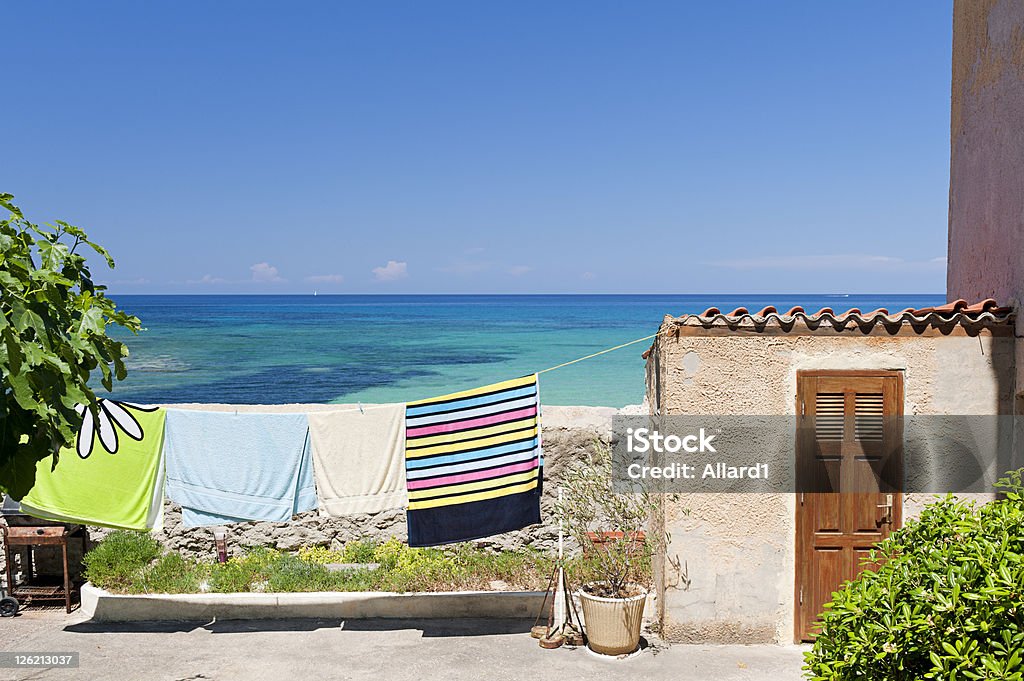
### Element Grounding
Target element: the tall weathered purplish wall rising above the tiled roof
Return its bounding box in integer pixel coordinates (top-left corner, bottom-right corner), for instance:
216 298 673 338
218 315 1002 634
946 0 1024 414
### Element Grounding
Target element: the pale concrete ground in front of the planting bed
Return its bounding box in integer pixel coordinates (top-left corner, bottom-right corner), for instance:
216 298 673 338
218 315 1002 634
0 608 802 681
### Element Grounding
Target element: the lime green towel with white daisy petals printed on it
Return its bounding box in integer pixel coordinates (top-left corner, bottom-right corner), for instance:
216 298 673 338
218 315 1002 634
22 399 167 530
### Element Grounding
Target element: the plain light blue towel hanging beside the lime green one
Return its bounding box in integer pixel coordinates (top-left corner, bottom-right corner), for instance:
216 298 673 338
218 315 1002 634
164 409 316 527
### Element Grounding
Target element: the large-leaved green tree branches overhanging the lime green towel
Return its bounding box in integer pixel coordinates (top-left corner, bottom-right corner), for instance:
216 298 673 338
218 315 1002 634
0 193 141 499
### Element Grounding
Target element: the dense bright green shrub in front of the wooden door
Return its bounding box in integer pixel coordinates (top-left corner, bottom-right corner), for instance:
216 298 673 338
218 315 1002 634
805 489 1024 681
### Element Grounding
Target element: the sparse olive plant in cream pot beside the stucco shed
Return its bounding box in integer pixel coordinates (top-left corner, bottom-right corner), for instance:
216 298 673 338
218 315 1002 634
555 441 665 655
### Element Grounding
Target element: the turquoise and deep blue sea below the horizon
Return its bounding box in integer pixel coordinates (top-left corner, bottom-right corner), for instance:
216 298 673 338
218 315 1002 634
101 294 944 407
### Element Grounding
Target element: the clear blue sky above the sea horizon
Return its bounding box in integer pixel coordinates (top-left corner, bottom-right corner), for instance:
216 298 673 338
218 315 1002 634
0 0 951 293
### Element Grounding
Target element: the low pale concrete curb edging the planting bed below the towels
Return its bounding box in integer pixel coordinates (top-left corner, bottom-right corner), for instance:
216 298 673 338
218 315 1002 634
82 584 544 622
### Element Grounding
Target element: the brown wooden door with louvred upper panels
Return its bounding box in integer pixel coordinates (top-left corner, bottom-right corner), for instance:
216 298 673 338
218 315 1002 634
795 371 903 641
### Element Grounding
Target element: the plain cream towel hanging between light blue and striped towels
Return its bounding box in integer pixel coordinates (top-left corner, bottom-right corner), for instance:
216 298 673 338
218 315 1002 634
308 405 409 515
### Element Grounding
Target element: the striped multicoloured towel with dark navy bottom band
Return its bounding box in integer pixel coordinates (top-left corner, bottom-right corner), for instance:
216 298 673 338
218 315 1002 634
406 374 544 546
